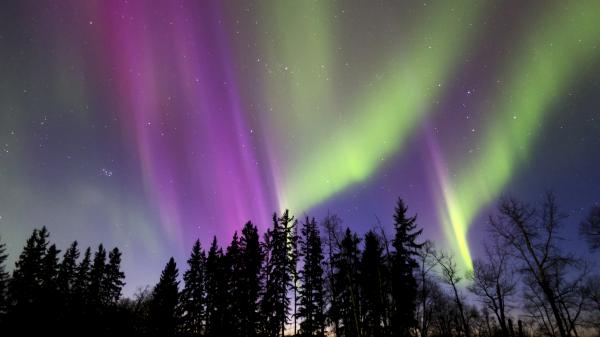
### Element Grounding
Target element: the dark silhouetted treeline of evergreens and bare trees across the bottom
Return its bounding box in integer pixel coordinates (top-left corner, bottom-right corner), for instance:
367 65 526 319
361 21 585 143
0 195 600 337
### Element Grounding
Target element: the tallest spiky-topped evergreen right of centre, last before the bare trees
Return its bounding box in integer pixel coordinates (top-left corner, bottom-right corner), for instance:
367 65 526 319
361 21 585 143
391 198 423 337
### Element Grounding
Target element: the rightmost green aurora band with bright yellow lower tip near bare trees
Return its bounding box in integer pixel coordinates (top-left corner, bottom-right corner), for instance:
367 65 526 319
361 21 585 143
431 1 600 269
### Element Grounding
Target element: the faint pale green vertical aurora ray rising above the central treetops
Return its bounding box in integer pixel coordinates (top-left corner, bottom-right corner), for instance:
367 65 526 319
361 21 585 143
257 1 336 210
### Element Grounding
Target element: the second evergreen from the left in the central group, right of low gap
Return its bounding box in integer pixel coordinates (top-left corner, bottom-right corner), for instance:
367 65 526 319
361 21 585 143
181 240 206 336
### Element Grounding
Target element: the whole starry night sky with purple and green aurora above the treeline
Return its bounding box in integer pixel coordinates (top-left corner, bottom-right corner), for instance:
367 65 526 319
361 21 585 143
0 0 600 292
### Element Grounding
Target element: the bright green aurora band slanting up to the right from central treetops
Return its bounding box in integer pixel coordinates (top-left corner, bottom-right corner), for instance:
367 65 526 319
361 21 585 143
270 1 482 211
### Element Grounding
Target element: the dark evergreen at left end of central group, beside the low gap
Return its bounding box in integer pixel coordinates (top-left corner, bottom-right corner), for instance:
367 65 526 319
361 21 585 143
149 258 179 336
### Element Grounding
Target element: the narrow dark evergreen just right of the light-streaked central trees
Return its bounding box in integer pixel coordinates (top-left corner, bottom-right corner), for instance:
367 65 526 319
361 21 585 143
297 217 325 336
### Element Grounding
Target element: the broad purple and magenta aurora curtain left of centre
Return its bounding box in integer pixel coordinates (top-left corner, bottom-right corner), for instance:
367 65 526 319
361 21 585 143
98 2 273 242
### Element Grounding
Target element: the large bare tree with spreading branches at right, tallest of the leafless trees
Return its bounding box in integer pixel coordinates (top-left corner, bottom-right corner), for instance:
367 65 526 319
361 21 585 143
490 193 578 337
